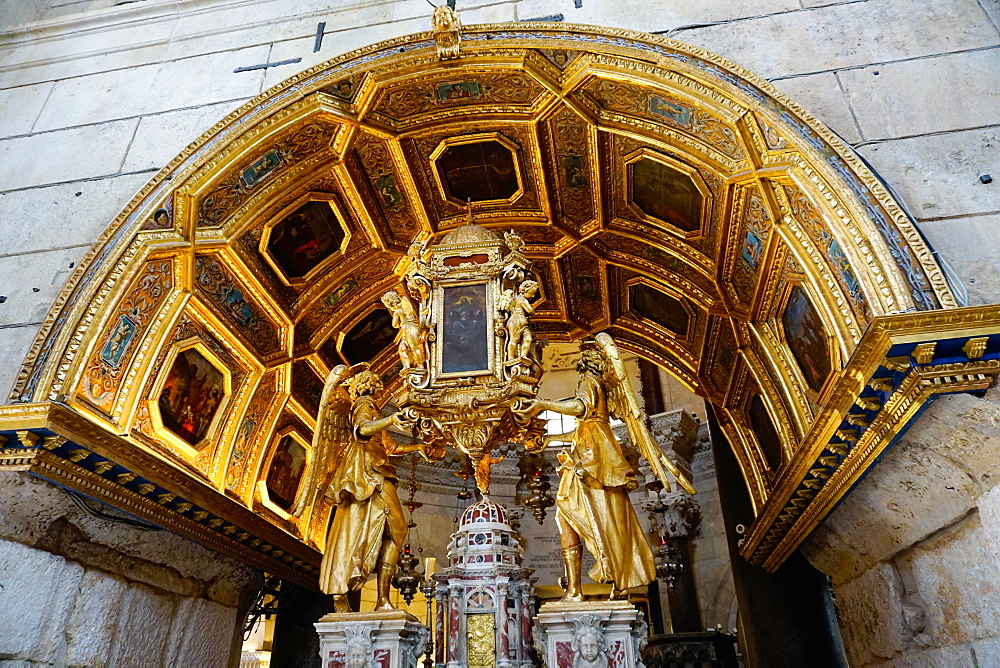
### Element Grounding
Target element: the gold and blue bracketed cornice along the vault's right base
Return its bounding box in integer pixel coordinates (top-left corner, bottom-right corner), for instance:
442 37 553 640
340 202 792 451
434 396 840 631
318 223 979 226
741 306 1000 572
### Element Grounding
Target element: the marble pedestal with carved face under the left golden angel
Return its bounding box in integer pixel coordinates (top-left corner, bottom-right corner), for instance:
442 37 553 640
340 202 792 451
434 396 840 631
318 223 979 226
316 610 430 668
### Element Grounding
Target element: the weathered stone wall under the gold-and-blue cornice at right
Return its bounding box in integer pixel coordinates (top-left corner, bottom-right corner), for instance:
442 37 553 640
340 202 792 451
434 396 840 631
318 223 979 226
803 388 1000 668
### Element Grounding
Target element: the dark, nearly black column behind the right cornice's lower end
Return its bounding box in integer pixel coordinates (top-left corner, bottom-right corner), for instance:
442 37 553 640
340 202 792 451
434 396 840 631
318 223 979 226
706 405 847 668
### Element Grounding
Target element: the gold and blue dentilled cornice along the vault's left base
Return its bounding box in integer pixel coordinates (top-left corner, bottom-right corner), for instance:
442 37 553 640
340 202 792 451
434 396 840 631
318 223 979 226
0 402 320 588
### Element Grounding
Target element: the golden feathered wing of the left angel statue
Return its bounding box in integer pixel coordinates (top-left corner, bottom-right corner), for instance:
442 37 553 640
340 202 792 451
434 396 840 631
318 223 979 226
292 364 351 515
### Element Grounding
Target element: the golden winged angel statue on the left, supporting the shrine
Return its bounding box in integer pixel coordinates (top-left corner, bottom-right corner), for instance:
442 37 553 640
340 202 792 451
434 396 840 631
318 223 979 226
292 364 429 612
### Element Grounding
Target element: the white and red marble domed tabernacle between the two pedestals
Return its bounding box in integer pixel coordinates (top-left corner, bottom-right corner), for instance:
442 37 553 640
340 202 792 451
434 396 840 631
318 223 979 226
433 497 538 668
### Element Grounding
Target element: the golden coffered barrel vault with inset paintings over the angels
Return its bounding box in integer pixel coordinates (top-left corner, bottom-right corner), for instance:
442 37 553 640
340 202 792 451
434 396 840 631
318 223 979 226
0 24 996 579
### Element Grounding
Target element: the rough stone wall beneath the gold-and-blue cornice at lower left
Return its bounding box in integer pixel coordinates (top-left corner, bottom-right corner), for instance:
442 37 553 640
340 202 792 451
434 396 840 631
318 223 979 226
0 473 259 668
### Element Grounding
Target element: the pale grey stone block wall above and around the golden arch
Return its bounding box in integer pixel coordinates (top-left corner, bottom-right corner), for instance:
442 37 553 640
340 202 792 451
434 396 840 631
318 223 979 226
0 0 1000 394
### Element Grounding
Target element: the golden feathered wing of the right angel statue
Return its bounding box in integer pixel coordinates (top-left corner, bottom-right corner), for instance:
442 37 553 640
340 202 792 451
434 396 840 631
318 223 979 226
595 332 695 494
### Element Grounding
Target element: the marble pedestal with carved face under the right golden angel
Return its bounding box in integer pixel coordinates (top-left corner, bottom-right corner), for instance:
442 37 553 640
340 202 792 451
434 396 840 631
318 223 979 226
535 601 647 668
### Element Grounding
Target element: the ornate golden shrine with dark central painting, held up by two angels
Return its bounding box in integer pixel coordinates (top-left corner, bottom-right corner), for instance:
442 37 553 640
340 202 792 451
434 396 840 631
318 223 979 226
383 205 544 494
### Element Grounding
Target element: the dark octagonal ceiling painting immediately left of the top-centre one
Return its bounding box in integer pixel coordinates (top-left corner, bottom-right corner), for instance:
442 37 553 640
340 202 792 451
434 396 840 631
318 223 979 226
267 201 344 278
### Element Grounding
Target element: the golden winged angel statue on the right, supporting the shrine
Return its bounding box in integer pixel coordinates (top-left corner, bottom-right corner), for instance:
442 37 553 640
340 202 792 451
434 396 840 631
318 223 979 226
522 333 694 602
